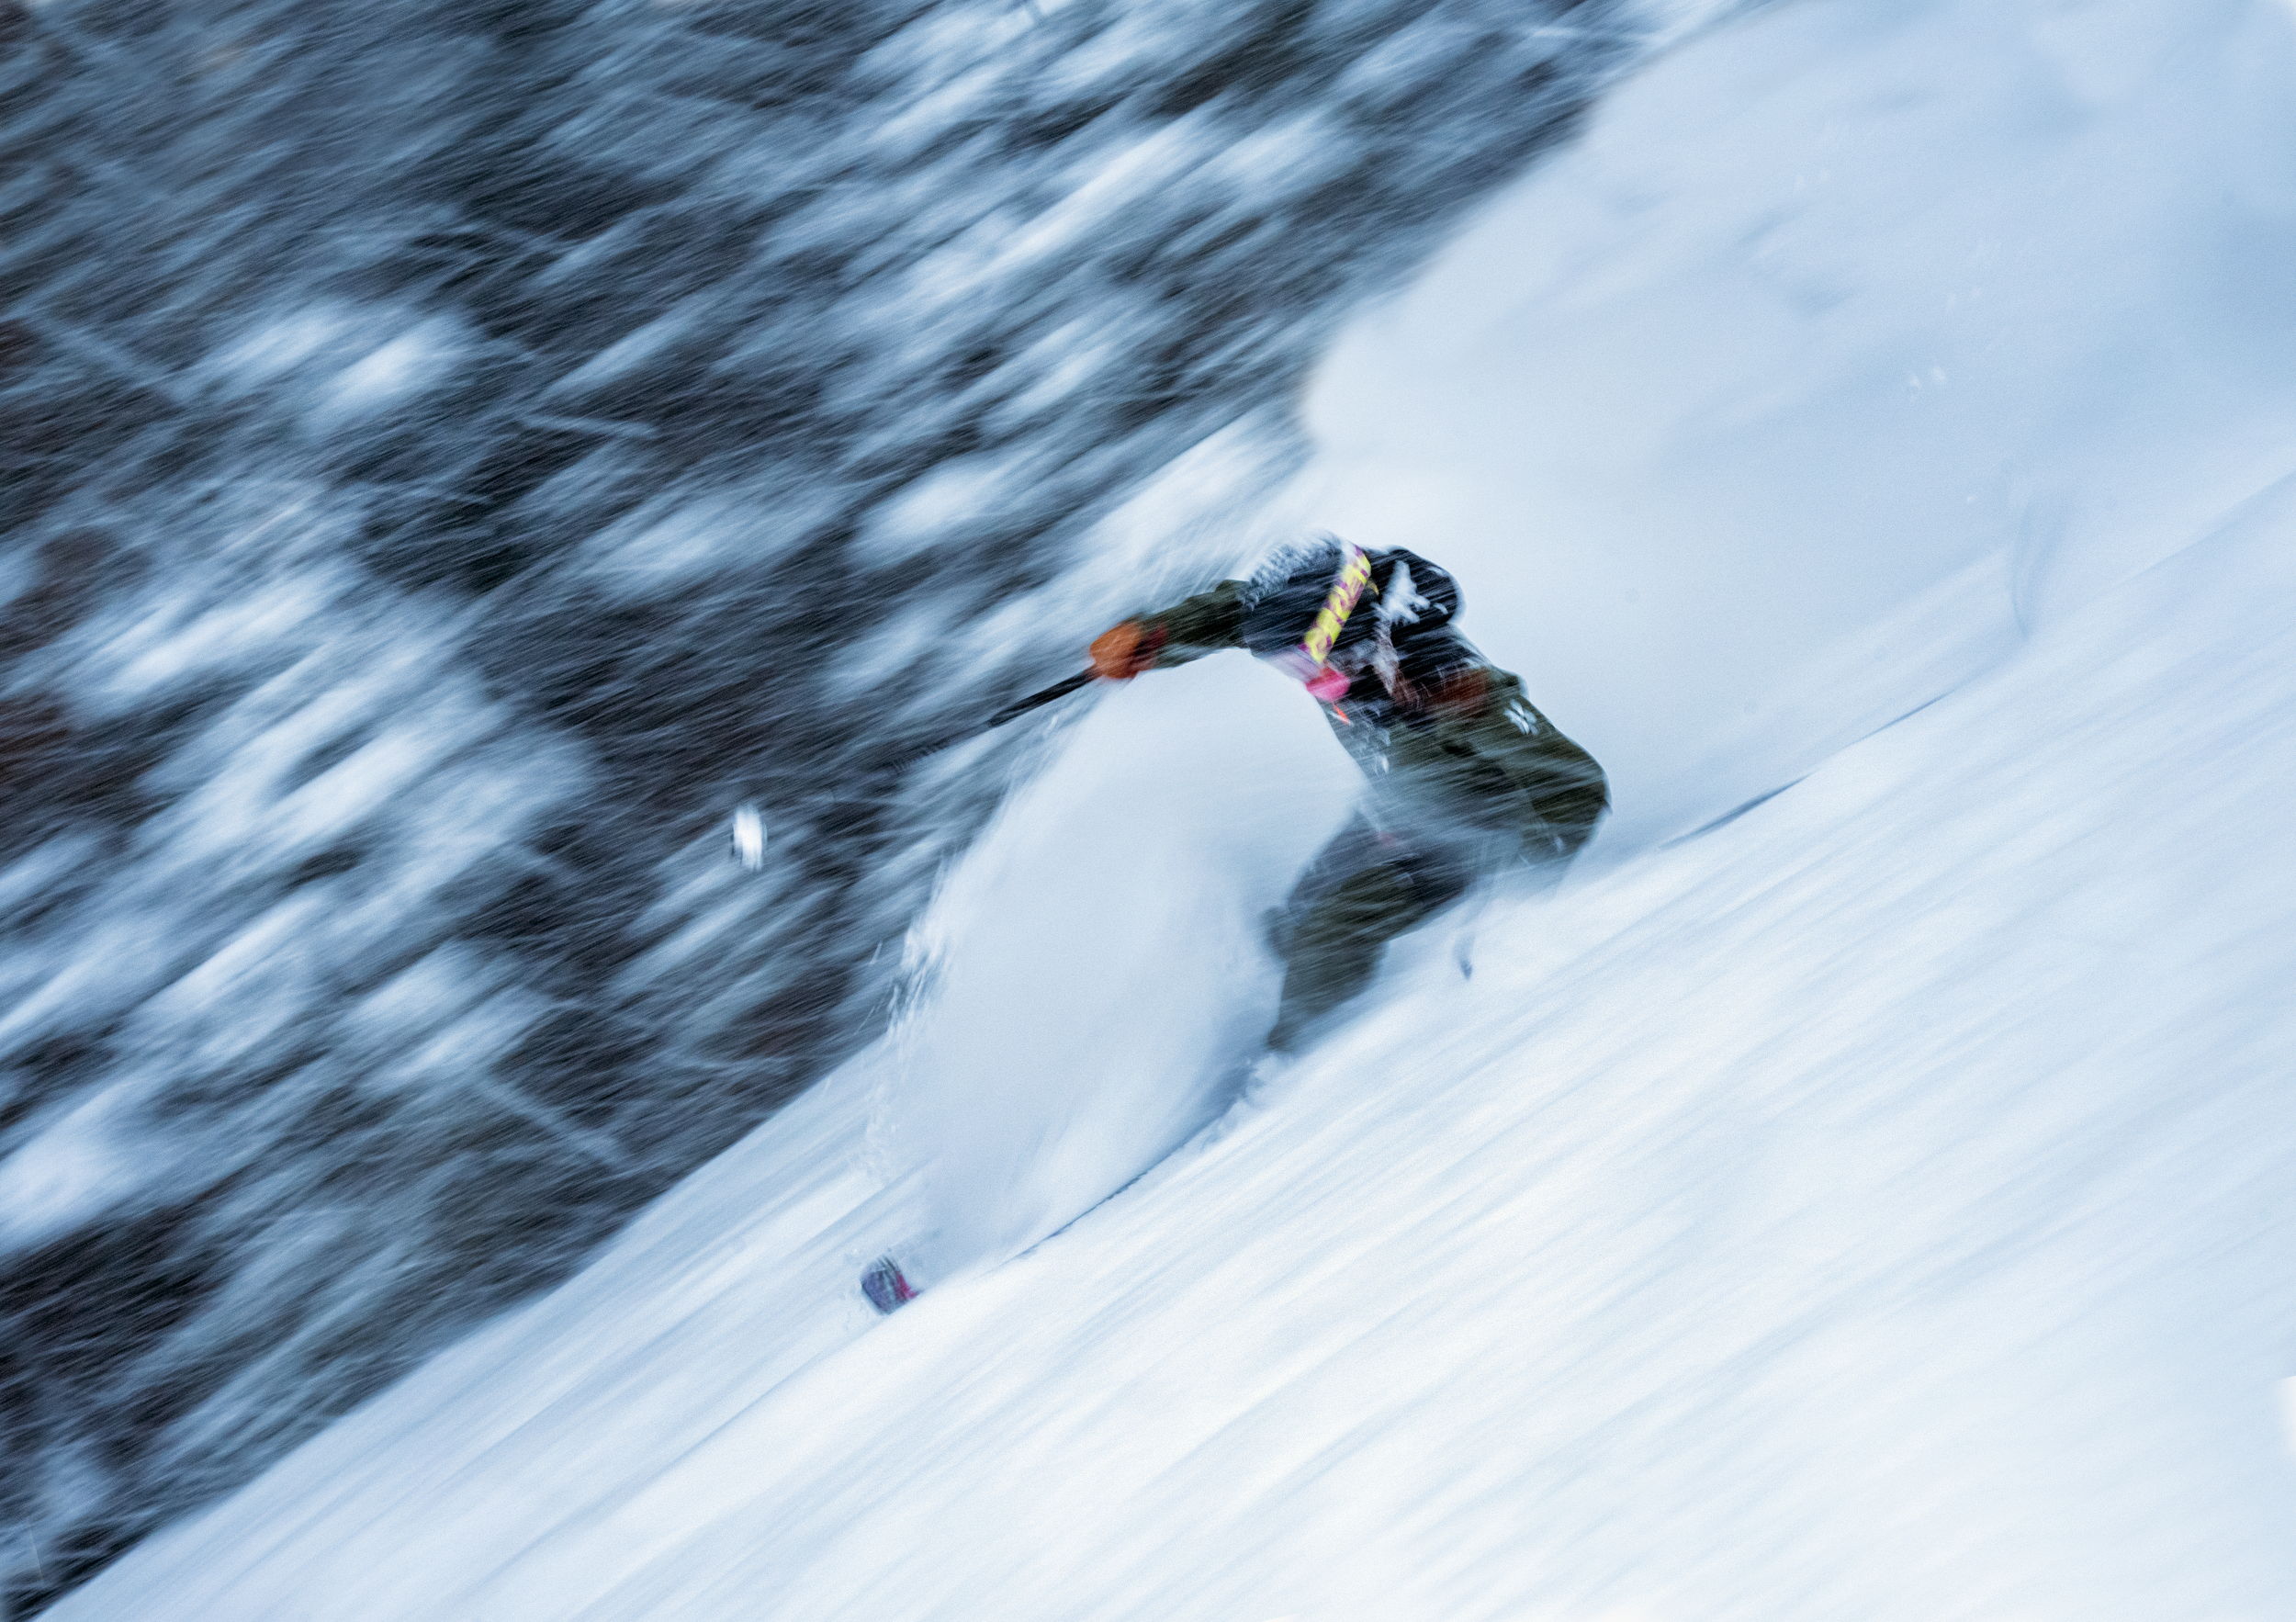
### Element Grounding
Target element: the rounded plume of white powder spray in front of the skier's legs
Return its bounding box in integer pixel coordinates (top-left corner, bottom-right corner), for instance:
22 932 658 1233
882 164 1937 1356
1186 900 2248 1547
871 652 1359 1282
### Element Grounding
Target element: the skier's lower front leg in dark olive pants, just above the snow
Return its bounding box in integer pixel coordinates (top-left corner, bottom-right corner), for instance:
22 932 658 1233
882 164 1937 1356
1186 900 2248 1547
1267 816 1520 1053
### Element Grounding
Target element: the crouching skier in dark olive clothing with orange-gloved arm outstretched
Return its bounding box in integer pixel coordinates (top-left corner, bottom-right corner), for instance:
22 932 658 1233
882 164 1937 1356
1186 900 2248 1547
1091 535 1610 1053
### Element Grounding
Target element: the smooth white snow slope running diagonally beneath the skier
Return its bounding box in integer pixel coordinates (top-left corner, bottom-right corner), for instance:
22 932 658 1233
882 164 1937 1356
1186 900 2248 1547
58 436 2296 1622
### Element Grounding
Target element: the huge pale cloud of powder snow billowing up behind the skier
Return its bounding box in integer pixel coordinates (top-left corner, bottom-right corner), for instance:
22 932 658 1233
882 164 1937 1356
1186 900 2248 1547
1302 0 2296 841
